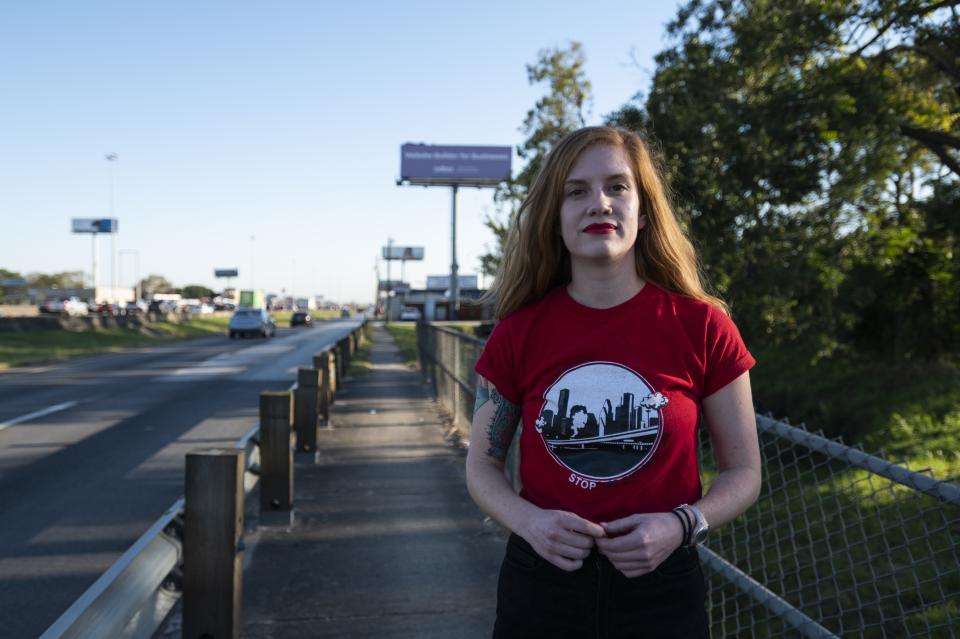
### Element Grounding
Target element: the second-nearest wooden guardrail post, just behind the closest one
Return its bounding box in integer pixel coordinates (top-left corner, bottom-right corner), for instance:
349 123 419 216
260 391 293 512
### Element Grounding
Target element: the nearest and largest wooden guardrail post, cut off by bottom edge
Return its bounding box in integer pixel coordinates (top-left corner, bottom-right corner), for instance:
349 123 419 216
182 448 245 639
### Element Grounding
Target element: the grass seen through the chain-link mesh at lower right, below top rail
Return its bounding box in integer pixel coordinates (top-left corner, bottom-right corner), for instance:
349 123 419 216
703 436 960 637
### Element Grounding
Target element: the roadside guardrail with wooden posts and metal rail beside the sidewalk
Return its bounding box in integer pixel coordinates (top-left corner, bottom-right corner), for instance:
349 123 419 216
41 321 366 639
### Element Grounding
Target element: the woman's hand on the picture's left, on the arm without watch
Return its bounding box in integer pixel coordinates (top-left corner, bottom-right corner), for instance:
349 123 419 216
517 508 605 572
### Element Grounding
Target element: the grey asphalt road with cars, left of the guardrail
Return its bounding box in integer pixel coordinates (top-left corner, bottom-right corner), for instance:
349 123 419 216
0 319 359 638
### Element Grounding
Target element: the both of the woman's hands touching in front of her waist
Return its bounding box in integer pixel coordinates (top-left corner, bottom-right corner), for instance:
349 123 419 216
522 510 683 577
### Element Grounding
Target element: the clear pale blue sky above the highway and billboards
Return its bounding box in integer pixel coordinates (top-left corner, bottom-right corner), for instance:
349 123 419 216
0 0 677 301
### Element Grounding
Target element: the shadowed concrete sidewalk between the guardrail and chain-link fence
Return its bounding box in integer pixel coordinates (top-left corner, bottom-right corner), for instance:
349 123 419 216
243 326 504 639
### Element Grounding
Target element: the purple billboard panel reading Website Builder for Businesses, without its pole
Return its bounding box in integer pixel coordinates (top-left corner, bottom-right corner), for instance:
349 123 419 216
400 144 513 186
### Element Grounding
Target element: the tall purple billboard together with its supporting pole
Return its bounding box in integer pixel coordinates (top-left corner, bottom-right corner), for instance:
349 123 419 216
397 144 512 319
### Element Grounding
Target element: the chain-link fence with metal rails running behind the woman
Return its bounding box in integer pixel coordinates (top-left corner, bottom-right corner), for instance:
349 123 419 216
417 323 960 638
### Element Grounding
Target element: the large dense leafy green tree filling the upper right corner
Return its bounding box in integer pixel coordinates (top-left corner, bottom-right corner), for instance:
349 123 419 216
610 0 960 360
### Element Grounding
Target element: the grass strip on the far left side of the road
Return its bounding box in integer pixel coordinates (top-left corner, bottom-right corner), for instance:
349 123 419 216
0 316 230 370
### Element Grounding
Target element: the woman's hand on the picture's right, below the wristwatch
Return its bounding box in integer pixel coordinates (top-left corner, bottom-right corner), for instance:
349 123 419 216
596 513 683 577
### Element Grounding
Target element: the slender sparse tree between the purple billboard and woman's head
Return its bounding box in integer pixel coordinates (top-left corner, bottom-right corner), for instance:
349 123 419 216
480 42 591 275
